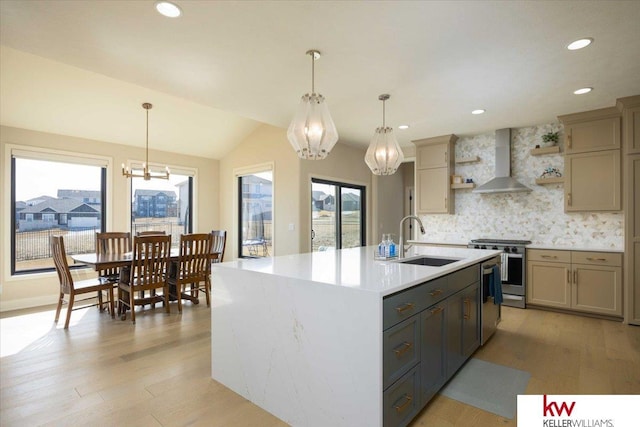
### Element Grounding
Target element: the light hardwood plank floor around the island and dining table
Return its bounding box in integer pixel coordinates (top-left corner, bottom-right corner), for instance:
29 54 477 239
0 303 640 427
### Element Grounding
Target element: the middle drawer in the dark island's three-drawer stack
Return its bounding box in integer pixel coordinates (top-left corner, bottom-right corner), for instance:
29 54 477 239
382 316 420 389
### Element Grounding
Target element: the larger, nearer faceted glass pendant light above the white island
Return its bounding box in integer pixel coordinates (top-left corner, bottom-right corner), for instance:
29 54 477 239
287 50 338 160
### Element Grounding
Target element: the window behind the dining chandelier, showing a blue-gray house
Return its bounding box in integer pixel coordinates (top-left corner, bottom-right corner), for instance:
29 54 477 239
131 171 193 247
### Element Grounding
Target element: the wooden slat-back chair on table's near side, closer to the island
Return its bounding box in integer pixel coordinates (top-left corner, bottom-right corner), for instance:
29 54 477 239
169 233 212 313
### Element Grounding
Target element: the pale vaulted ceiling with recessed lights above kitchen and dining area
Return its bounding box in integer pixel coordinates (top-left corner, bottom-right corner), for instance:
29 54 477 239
0 0 640 158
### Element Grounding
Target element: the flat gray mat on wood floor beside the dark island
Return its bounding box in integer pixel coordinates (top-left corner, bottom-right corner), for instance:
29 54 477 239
440 358 531 419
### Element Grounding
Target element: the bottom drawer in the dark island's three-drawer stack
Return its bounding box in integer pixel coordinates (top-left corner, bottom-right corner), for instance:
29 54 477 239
382 366 421 427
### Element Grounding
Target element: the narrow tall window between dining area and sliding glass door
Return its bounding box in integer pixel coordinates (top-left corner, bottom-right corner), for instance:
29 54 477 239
238 170 273 258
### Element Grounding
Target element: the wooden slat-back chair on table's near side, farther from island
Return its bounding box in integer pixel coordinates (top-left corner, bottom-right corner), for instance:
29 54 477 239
118 236 171 323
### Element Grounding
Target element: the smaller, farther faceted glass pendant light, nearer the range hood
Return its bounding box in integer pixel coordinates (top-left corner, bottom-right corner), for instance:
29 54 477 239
364 93 404 175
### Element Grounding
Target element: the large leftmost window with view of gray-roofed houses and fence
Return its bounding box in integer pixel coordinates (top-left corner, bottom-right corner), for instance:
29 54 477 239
11 154 107 274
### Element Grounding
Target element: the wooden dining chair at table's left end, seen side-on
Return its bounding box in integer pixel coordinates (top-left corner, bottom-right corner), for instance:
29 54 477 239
51 236 115 329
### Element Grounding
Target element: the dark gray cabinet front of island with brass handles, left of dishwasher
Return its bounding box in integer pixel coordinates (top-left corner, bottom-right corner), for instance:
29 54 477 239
383 265 480 427
